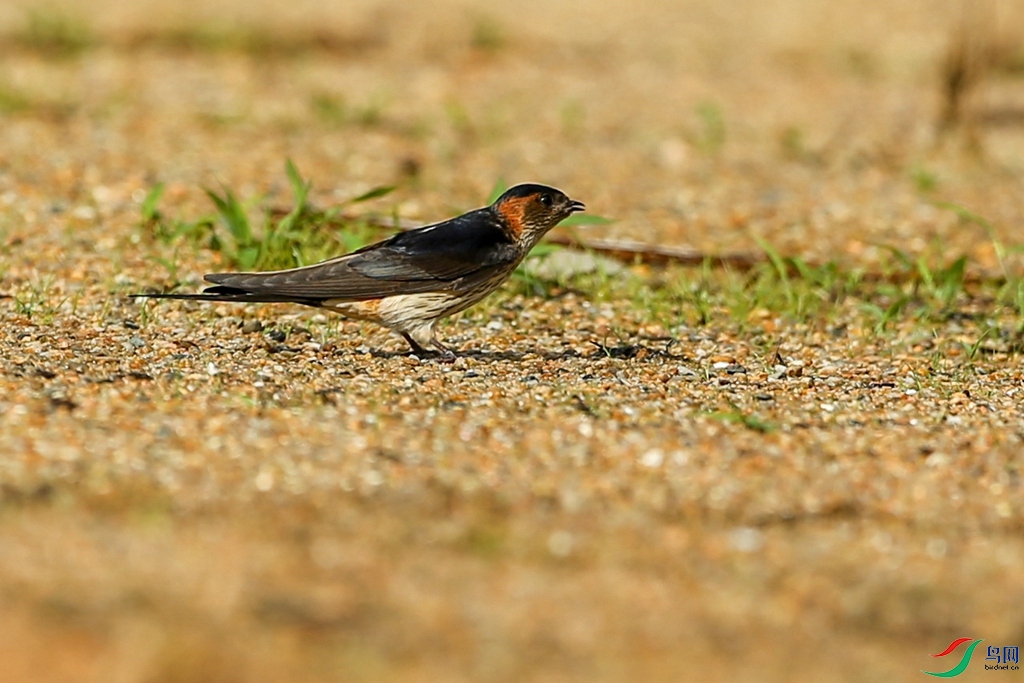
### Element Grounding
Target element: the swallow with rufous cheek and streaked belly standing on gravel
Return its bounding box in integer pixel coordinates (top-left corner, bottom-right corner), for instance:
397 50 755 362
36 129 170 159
132 183 586 362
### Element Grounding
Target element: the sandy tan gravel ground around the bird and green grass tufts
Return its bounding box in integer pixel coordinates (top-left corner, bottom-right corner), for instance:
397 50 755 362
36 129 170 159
0 0 1024 682
